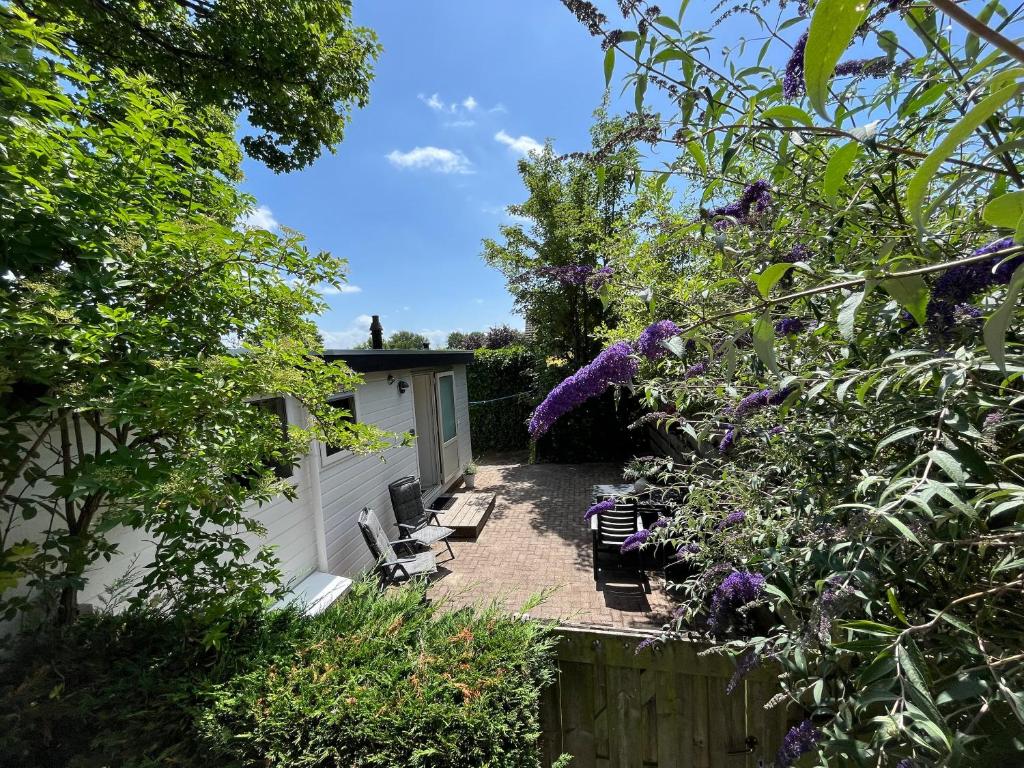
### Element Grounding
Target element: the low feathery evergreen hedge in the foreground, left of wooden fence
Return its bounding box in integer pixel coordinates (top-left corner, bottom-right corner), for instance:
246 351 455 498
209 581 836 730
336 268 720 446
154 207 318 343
0 582 553 768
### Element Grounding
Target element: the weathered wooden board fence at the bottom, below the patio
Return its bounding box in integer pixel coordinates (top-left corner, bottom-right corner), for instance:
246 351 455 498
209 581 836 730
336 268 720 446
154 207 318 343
541 628 787 768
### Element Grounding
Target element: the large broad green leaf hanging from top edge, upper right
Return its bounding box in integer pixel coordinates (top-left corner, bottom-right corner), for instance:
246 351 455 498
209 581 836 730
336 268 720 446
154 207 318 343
804 0 867 120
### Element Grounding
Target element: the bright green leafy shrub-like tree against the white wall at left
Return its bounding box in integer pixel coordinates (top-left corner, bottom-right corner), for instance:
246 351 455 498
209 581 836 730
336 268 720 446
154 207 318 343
0 13 385 630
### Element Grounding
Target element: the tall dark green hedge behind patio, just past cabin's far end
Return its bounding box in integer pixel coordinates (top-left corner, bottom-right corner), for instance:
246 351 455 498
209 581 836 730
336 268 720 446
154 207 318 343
466 346 537 453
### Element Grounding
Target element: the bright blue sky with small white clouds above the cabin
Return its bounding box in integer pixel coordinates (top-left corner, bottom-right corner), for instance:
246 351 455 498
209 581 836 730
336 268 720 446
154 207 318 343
244 0 604 347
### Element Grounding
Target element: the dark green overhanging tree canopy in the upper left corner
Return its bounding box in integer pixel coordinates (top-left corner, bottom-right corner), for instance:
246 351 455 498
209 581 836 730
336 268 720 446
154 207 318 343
12 0 380 171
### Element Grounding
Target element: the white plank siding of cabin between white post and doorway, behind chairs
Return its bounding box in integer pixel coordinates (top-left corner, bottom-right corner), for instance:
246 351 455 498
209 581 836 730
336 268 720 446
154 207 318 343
321 371 420 575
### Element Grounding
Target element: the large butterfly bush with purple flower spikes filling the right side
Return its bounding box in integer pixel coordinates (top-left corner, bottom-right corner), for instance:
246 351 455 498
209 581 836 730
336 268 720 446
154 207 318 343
557 0 1024 768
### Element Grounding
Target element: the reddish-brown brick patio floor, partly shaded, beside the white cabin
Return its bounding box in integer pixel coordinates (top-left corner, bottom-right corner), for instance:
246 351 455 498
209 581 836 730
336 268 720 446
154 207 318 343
430 457 672 628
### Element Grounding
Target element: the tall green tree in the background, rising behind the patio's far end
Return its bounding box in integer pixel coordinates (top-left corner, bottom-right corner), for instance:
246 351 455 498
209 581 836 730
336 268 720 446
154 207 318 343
483 112 638 365
